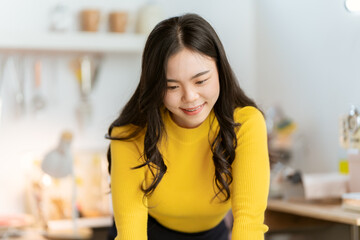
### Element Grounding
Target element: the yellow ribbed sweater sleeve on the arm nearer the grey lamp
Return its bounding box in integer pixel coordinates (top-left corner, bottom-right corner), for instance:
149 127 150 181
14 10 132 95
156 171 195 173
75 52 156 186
110 130 148 240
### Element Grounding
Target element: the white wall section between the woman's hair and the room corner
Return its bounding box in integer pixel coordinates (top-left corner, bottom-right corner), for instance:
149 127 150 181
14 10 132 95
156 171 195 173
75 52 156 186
157 0 256 98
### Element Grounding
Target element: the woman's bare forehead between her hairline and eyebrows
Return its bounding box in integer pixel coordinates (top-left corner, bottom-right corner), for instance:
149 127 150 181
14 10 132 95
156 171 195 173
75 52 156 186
166 48 216 80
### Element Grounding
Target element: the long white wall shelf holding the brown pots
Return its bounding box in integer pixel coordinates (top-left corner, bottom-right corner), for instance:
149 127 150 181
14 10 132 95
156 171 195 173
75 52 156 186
0 32 146 54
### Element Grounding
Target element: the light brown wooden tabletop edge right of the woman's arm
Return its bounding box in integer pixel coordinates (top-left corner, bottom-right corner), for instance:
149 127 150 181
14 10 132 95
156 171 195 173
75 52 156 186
267 199 360 240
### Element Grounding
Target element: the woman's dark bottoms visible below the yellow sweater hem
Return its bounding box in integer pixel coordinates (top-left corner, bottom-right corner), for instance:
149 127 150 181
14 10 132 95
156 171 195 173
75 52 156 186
108 215 229 240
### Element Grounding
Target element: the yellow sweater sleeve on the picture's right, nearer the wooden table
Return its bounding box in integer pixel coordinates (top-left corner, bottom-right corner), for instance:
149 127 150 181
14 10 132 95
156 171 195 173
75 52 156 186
231 107 270 240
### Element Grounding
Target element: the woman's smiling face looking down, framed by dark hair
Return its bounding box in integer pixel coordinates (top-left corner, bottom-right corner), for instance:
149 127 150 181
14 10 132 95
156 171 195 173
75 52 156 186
164 48 220 128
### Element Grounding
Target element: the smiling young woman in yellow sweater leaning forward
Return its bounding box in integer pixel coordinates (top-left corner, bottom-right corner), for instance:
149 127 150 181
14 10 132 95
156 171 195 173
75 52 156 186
108 14 269 240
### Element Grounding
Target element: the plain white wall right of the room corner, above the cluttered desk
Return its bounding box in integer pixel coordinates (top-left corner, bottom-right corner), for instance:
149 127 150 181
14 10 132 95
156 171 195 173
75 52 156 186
256 0 360 172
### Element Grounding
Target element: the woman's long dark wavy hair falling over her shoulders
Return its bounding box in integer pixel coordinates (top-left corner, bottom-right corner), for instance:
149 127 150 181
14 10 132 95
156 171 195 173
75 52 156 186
107 14 257 201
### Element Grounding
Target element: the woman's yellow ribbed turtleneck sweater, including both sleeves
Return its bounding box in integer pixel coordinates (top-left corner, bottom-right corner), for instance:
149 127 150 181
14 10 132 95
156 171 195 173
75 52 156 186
111 107 270 240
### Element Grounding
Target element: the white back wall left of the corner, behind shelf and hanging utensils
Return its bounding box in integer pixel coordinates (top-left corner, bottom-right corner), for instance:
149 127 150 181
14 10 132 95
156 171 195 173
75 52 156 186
0 0 256 214
